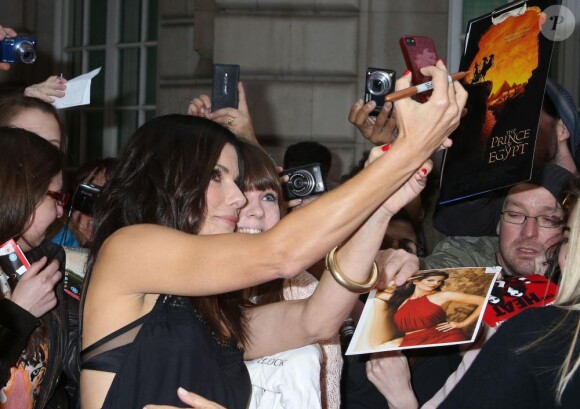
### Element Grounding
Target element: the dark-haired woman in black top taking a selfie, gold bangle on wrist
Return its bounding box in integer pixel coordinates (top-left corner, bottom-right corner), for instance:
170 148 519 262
81 63 466 408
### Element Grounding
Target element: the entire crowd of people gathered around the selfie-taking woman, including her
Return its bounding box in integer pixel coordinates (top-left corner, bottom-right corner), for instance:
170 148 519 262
0 20 580 409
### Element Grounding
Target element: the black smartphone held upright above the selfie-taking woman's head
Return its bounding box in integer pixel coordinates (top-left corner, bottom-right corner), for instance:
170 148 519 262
211 64 240 112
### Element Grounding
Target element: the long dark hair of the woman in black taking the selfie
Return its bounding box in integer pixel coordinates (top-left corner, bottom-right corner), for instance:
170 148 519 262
81 114 247 342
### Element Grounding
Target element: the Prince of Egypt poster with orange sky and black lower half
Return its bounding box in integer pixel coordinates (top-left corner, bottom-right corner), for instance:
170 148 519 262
439 0 558 203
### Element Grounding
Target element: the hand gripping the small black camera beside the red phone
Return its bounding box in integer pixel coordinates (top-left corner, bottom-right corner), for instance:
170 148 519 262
348 99 397 145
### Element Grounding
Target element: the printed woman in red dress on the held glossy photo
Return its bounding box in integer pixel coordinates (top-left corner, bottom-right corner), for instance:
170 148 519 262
377 271 485 347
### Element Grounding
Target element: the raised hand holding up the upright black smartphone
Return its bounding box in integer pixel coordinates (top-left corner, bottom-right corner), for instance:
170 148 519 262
187 81 259 145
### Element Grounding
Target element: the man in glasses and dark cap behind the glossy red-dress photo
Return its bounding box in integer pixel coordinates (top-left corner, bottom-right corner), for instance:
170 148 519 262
421 164 572 276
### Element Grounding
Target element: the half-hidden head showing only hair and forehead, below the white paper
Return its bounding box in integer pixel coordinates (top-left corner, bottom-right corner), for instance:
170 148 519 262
0 94 67 152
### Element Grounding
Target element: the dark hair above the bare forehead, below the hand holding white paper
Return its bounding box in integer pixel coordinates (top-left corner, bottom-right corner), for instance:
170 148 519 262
0 93 67 153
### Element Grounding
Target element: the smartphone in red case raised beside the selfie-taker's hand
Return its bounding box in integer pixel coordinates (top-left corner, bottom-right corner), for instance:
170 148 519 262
399 35 439 85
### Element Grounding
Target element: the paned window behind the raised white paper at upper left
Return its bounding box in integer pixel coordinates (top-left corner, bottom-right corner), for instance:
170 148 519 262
62 0 158 166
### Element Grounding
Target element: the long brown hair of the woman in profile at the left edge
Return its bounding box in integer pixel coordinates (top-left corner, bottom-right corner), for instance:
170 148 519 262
0 127 62 247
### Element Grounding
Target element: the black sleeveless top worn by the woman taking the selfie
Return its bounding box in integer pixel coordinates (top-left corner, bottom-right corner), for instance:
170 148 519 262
81 295 251 409
